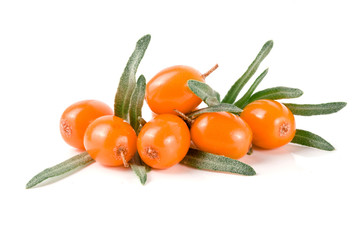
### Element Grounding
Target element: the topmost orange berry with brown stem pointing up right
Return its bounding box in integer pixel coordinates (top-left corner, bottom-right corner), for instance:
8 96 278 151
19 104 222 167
146 65 217 114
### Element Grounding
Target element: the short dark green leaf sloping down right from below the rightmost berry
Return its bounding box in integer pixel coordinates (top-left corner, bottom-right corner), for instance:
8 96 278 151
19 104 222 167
291 129 335 151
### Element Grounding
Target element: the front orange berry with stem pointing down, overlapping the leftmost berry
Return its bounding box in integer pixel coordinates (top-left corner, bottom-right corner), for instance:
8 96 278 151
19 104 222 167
84 116 137 167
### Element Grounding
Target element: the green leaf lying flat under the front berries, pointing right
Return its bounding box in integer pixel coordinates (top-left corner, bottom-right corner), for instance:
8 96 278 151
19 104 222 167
181 149 256 176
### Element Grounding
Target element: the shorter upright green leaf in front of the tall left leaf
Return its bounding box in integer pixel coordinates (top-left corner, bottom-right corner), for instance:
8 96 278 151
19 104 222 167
129 75 146 134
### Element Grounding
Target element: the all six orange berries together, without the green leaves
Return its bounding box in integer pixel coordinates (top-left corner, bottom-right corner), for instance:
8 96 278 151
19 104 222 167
60 63 296 169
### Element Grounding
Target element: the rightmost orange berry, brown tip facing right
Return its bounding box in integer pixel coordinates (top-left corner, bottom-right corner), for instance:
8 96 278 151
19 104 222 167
240 100 296 149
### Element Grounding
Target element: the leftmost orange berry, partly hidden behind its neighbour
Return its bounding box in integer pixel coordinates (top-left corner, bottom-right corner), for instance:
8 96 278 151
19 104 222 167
60 100 113 150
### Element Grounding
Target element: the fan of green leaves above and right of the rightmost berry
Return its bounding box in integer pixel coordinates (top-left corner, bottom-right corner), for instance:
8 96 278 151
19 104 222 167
188 40 346 151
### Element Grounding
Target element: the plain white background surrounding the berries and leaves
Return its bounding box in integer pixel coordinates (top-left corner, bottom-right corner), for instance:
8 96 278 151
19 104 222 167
0 0 360 240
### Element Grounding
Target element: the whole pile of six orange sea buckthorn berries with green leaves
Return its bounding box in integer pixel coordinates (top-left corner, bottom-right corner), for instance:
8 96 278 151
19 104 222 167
26 35 346 188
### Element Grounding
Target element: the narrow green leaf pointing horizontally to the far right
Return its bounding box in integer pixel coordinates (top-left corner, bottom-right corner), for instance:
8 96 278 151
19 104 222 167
284 102 346 116
